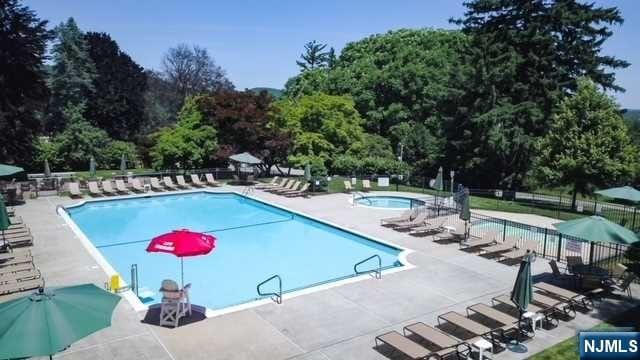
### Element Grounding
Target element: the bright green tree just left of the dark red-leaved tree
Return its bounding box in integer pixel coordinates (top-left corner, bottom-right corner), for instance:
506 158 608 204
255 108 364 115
151 97 218 169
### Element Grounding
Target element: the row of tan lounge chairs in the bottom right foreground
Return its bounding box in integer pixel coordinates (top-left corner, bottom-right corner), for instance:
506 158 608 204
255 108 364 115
374 282 594 359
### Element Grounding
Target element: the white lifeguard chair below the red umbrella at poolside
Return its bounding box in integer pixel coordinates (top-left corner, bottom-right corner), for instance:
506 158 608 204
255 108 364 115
158 280 191 327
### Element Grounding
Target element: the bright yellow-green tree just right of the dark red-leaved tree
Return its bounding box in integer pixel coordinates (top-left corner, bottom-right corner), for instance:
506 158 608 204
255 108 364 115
272 93 364 167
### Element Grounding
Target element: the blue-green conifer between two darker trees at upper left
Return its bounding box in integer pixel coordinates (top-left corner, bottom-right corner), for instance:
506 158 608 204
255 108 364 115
45 18 96 133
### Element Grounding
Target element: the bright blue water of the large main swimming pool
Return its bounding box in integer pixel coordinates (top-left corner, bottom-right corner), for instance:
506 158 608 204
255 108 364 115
67 192 401 309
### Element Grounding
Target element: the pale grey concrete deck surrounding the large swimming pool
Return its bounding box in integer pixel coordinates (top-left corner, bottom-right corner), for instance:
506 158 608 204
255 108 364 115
6 188 638 360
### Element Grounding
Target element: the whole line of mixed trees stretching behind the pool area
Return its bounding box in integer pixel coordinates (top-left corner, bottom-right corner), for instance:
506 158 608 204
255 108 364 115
0 0 638 204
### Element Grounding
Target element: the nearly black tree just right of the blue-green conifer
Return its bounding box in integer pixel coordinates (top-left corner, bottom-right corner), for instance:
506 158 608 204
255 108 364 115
84 32 147 139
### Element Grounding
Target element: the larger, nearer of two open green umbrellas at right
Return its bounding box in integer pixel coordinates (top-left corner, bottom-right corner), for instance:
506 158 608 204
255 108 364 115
553 215 639 244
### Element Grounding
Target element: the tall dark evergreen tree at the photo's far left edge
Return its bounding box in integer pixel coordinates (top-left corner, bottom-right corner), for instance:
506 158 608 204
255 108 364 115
0 0 52 166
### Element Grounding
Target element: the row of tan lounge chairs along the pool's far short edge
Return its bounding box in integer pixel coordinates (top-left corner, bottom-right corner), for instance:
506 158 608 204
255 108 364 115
69 173 221 197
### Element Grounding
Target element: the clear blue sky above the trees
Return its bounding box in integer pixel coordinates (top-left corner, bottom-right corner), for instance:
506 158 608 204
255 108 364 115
24 0 640 109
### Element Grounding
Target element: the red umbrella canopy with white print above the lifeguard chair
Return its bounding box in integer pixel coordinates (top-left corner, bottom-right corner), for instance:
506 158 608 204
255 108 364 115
147 229 216 257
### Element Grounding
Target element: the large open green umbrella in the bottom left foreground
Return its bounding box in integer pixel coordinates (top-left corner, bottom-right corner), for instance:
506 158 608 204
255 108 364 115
0 284 120 359
